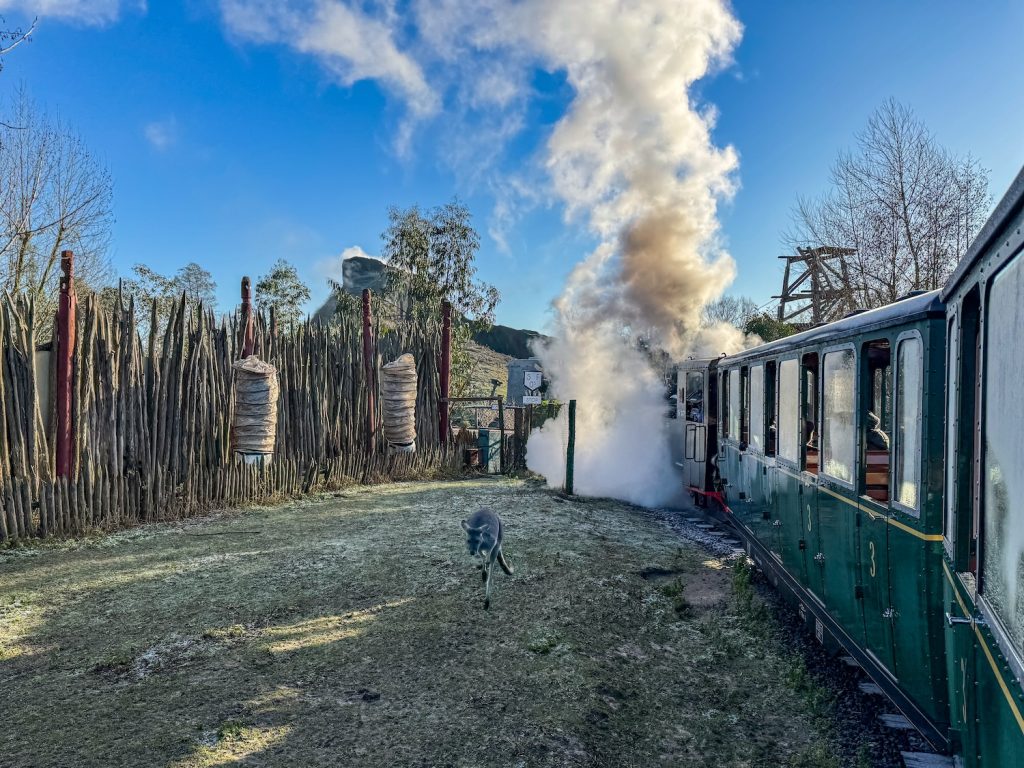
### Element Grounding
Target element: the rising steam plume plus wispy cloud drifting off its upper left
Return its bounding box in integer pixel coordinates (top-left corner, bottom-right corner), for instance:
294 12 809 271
221 0 743 505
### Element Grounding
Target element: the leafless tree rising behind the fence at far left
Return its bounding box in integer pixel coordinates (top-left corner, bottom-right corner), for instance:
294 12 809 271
0 89 114 315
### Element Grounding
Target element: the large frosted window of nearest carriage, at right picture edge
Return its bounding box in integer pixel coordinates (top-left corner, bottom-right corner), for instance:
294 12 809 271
981 256 1024 652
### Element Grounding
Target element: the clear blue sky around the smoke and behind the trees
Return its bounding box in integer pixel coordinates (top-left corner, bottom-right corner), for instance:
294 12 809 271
0 0 1024 328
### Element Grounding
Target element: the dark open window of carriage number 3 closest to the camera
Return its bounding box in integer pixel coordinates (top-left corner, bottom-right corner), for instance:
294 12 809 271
861 339 892 504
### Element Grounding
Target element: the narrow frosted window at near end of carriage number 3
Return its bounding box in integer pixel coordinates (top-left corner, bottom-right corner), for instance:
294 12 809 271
893 338 924 510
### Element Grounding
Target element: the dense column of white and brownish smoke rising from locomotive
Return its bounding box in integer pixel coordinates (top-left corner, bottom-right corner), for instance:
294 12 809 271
507 0 743 512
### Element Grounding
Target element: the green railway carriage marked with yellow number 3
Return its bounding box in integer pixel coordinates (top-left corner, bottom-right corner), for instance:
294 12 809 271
704 293 948 748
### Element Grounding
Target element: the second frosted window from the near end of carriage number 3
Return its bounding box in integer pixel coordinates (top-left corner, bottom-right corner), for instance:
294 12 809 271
821 349 856 483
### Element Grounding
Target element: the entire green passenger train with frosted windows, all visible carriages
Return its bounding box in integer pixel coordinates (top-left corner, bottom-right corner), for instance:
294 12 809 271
677 166 1024 767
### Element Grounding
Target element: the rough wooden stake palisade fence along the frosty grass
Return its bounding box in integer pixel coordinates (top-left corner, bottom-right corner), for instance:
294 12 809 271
0 268 453 542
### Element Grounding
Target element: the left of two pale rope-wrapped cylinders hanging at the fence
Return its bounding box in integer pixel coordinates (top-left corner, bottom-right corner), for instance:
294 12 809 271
231 355 279 455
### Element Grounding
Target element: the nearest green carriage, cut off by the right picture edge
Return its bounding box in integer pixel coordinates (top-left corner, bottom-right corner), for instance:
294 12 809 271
942 171 1024 766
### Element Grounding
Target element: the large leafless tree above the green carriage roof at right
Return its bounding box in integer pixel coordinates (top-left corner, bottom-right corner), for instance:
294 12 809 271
787 100 990 308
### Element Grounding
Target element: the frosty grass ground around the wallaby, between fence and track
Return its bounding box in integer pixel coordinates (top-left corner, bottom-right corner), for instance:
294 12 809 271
0 480 824 768
